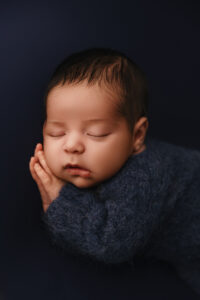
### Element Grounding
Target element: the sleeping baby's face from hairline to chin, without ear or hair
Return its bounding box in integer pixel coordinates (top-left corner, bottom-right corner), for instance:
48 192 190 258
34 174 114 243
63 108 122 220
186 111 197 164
43 80 133 188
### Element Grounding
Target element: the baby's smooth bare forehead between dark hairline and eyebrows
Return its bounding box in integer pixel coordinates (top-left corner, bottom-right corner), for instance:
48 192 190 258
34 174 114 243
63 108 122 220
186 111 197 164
46 85 120 120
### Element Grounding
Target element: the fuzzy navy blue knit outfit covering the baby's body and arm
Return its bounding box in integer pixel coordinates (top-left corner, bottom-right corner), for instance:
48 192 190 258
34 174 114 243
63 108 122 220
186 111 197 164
42 137 200 294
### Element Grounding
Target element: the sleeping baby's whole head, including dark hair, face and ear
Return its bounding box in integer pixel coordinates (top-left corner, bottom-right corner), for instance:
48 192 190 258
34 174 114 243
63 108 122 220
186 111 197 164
43 48 148 188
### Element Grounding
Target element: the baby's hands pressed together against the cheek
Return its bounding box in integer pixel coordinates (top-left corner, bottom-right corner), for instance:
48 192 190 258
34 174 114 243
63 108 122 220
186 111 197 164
29 144 66 212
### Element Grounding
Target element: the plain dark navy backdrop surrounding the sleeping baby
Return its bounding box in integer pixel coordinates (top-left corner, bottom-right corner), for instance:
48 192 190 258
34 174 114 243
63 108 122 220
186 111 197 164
0 0 200 300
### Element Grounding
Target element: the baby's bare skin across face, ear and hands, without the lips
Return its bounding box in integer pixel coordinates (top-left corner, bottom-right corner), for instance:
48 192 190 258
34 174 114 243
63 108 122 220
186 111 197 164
30 83 148 211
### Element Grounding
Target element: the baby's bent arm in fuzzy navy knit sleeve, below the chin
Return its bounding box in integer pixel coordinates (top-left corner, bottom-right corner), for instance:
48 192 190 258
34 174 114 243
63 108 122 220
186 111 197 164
31 151 159 263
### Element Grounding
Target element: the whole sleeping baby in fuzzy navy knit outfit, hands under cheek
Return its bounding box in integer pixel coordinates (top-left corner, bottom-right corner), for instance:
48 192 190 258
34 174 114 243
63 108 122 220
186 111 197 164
29 48 200 294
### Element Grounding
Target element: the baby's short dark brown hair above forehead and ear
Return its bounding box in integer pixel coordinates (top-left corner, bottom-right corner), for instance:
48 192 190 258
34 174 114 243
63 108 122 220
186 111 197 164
43 48 148 133
